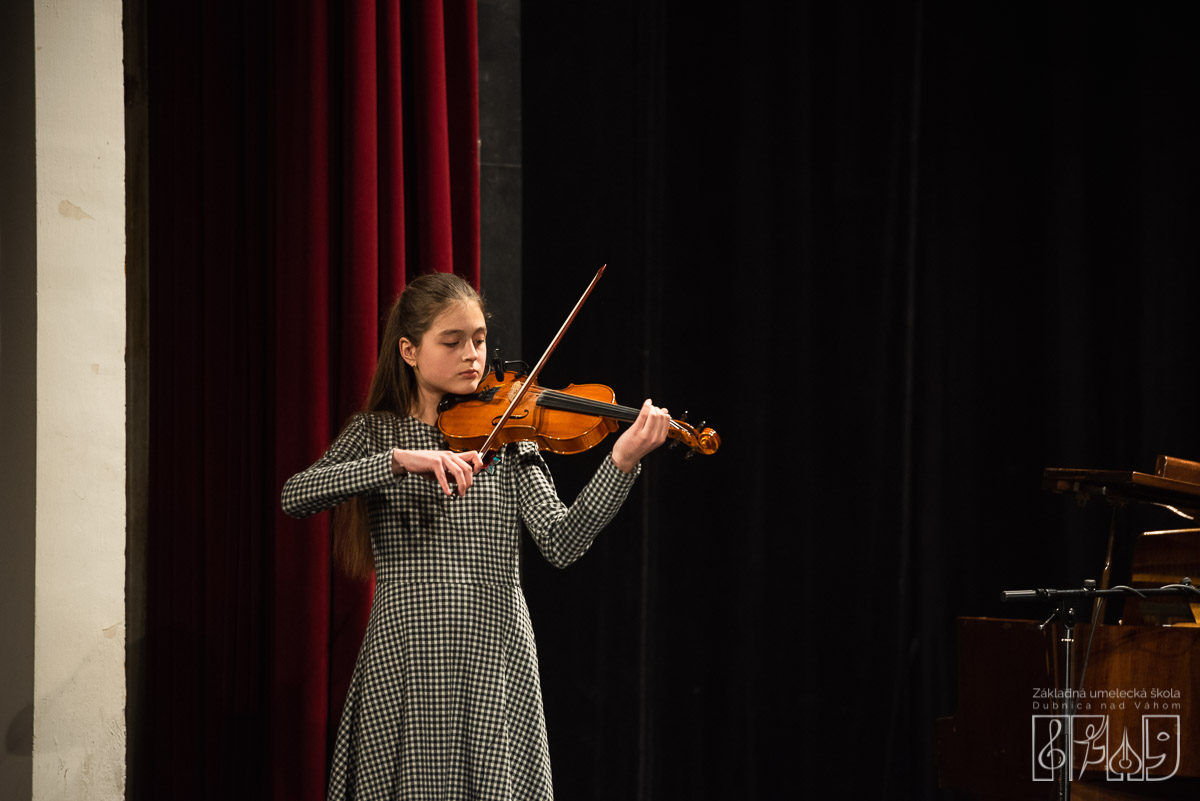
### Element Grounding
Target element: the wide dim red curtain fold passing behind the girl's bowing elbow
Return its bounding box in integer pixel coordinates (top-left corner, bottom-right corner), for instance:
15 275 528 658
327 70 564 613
264 0 337 799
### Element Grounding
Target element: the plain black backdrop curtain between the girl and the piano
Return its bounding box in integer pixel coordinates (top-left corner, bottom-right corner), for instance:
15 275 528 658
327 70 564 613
520 0 1200 799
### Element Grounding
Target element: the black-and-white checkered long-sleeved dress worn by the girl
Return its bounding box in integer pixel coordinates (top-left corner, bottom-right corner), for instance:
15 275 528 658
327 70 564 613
283 415 636 801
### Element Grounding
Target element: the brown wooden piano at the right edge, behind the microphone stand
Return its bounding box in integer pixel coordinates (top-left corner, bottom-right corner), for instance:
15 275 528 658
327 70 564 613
935 457 1200 801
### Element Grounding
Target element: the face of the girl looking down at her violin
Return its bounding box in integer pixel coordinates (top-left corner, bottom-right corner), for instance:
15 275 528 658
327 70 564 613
400 302 487 409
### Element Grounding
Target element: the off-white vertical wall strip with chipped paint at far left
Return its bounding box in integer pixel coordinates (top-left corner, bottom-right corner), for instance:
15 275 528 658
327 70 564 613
32 0 126 801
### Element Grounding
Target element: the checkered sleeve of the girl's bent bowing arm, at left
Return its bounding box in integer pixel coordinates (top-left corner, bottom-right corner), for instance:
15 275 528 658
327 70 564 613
281 415 403 518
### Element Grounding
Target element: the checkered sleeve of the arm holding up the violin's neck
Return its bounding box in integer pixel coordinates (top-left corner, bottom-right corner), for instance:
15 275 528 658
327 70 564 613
515 442 642 567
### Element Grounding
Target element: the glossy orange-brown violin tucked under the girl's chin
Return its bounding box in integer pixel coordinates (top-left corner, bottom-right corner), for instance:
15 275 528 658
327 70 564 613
438 368 721 456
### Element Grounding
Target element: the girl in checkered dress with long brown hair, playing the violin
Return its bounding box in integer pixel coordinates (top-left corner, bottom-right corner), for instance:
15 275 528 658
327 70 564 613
282 273 671 801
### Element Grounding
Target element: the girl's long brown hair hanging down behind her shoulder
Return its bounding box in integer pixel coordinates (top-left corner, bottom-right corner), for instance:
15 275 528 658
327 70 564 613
334 272 487 579
